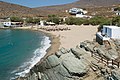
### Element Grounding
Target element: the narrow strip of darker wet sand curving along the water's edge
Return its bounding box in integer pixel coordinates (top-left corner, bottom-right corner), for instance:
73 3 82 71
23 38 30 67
0 27 60 78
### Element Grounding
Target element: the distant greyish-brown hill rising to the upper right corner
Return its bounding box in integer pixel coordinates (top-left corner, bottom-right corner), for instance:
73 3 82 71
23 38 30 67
36 0 120 11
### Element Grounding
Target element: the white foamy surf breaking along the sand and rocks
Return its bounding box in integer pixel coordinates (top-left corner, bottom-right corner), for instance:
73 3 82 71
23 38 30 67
11 36 51 80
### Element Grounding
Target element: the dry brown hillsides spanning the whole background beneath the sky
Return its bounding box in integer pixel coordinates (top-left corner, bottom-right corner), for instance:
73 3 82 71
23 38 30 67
0 0 120 18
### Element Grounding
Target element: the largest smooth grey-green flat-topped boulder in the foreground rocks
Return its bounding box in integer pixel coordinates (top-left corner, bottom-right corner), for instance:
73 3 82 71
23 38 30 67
62 57 88 76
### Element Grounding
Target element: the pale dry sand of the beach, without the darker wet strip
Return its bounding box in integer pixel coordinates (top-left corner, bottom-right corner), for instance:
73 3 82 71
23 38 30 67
40 25 98 49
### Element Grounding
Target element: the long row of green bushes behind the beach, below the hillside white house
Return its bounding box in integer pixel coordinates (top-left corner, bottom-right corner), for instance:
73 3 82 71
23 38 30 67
65 16 110 25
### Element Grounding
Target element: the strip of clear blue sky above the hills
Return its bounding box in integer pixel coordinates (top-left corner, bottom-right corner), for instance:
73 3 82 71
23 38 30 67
0 0 77 8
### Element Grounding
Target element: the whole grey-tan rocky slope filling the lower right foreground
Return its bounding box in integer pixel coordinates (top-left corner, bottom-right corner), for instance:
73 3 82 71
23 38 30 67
17 40 120 80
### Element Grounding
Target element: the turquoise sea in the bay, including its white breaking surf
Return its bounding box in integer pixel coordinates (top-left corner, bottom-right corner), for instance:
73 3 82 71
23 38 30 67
0 29 51 80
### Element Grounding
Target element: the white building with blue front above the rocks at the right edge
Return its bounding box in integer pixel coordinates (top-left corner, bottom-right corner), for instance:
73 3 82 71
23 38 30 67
96 25 120 44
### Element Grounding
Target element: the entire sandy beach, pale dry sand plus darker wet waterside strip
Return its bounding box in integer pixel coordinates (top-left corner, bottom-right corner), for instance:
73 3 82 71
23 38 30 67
0 25 97 80
